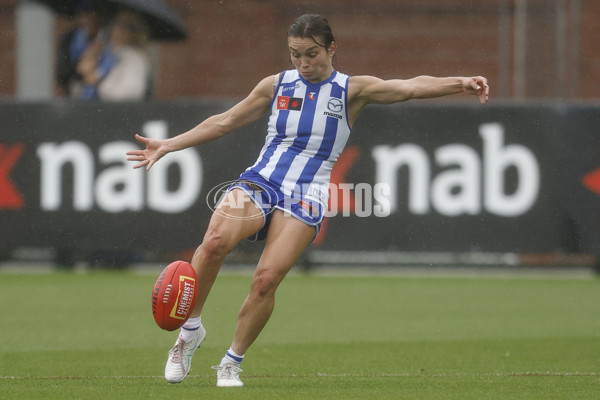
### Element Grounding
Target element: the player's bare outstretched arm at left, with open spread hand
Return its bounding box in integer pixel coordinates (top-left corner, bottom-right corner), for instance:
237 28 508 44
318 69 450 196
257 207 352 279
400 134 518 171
127 76 275 170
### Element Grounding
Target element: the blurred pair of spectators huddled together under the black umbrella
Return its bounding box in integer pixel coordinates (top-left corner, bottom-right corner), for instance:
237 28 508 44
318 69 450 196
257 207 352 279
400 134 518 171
56 0 152 101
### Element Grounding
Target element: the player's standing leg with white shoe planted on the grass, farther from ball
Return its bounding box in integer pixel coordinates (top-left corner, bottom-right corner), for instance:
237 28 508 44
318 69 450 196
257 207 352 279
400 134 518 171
213 210 315 387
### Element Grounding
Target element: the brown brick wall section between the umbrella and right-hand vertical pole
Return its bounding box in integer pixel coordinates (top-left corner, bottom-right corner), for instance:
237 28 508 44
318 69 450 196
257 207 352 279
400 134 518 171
157 0 498 97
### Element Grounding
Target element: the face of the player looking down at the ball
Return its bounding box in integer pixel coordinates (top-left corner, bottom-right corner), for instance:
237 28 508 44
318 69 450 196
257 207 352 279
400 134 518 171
288 37 335 83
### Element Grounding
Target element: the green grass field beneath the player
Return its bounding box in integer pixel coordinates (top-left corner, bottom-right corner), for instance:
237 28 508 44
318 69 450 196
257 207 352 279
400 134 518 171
0 271 600 400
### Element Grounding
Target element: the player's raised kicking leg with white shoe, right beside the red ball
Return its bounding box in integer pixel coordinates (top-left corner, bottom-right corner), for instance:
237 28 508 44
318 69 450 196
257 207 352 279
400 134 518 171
165 189 263 383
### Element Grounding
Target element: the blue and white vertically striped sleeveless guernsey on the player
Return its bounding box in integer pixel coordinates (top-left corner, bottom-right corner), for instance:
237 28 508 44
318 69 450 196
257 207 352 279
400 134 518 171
246 70 351 205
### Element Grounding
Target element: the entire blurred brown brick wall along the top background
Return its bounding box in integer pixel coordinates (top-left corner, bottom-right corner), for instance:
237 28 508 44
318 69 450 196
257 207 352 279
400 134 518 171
0 0 600 99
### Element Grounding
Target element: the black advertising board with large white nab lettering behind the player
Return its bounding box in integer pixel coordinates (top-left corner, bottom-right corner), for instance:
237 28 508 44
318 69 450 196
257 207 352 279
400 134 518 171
0 102 600 257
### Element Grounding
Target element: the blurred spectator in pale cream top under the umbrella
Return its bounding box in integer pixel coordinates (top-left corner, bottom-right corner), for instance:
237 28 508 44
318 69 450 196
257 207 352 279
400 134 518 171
77 10 150 101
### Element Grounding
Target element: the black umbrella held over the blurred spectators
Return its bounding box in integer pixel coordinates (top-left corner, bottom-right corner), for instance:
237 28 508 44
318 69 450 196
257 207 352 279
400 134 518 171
35 0 187 40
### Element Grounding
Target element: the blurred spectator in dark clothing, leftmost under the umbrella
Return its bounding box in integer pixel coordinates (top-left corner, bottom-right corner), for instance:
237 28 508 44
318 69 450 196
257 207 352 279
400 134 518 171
55 0 107 96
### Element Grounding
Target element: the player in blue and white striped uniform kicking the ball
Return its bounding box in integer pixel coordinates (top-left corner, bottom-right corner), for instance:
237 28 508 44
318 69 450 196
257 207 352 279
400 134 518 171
127 14 489 387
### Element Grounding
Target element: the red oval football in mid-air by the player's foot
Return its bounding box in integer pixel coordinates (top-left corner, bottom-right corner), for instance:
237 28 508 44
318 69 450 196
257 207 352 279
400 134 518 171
152 261 198 331
